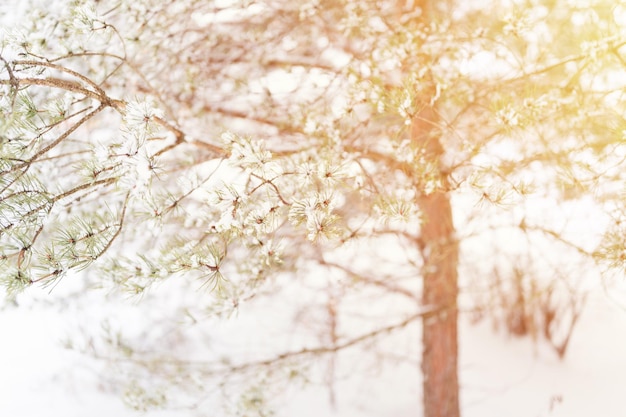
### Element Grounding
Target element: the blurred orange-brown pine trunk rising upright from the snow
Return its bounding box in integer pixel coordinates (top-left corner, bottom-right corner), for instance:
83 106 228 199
405 0 460 417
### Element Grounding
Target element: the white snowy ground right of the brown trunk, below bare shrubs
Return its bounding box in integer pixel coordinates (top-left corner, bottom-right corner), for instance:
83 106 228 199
461 290 626 417
